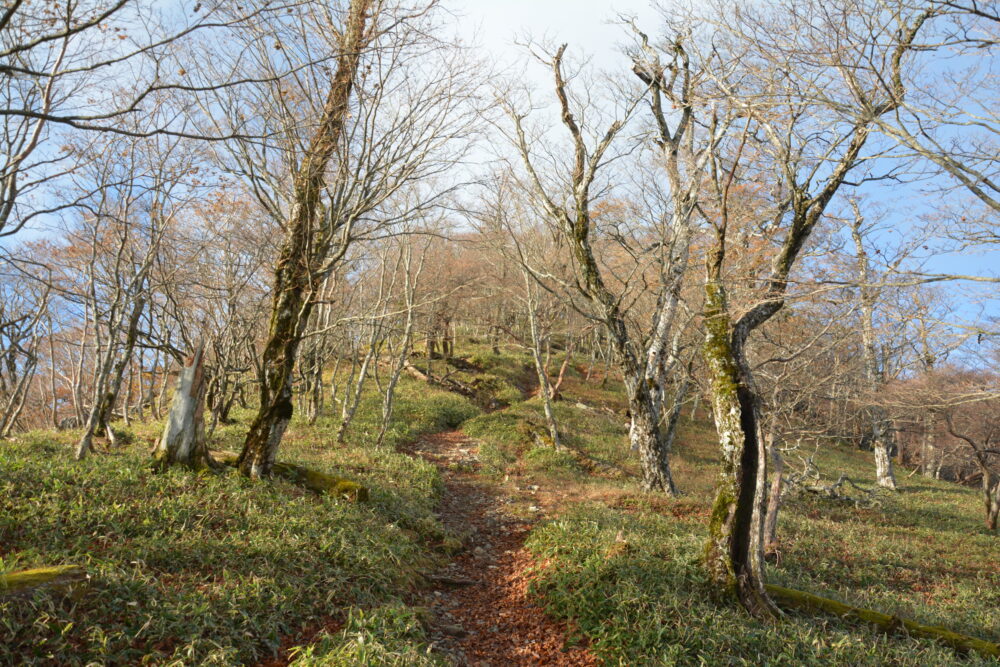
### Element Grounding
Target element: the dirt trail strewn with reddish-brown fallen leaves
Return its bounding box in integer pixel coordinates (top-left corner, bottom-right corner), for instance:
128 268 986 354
409 431 599 667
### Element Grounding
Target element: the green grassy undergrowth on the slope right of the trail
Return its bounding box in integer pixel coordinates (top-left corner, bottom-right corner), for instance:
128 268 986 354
504 366 1000 665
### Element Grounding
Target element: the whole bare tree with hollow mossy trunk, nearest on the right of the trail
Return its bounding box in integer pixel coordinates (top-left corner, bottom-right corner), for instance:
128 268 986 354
688 2 925 616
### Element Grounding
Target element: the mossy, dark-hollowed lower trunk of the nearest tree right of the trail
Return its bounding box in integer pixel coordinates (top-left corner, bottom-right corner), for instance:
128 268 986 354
704 279 776 617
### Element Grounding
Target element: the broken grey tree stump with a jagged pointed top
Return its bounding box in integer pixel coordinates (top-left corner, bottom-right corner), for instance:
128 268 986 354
153 344 212 469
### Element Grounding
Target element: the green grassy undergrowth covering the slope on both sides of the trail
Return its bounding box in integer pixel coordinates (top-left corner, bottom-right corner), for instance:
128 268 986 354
0 346 1000 666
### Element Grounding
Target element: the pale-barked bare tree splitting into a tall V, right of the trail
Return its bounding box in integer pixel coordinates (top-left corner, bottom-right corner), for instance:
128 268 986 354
505 35 721 494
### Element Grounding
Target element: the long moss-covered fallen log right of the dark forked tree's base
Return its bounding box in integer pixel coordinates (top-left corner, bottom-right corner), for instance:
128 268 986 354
766 584 1000 658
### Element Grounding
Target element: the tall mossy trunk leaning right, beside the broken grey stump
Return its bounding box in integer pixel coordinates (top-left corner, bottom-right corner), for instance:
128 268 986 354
237 0 372 478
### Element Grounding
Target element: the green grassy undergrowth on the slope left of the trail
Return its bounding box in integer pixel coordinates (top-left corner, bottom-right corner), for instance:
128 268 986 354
0 380 477 665
